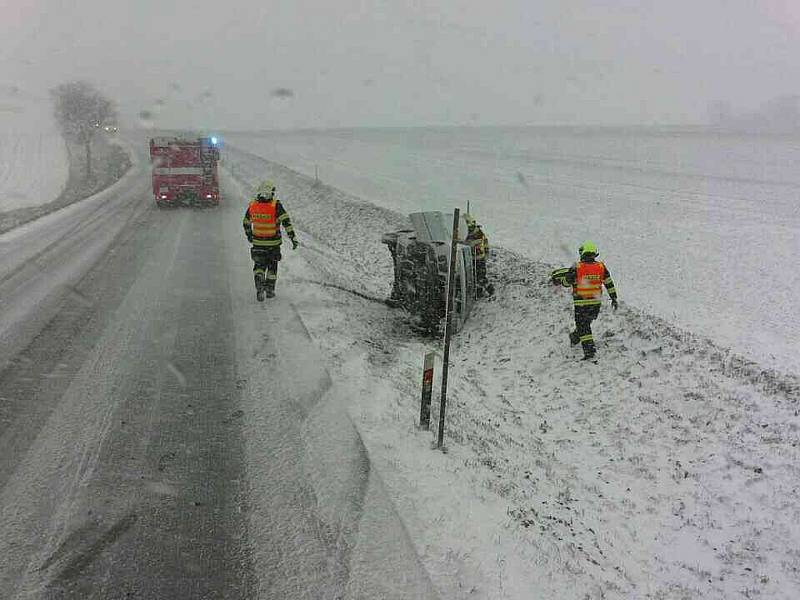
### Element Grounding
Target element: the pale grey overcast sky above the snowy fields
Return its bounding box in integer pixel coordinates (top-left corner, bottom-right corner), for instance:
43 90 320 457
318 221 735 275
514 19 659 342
0 0 800 129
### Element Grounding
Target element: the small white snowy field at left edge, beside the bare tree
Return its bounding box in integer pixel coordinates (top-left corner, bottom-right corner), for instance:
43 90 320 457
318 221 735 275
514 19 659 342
0 87 69 212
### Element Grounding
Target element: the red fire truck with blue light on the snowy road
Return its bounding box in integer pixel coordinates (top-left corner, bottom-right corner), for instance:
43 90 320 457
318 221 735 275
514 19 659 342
150 137 220 208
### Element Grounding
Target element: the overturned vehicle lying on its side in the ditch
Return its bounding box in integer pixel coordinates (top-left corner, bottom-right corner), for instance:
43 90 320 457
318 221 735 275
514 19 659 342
382 212 476 332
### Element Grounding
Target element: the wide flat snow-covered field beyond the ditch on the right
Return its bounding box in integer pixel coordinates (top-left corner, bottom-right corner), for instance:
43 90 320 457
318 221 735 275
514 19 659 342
227 128 800 373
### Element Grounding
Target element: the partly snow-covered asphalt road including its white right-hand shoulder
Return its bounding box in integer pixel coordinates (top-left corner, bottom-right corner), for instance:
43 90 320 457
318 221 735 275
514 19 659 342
0 148 435 599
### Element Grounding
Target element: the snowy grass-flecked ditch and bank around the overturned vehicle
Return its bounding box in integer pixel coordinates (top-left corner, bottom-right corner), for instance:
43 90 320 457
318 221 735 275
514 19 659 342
223 148 800 599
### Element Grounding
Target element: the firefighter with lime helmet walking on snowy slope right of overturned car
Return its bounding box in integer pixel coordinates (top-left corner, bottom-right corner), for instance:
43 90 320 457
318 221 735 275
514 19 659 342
550 241 618 360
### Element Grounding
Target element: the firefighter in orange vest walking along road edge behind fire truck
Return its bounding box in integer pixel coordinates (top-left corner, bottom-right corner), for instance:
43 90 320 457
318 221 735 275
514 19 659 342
242 181 298 302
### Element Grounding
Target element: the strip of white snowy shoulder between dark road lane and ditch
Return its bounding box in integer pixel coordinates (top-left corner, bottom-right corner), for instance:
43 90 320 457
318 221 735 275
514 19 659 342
222 172 438 600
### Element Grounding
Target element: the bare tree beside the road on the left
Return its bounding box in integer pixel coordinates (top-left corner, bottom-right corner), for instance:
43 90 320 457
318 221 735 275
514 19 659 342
51 81 117 179
